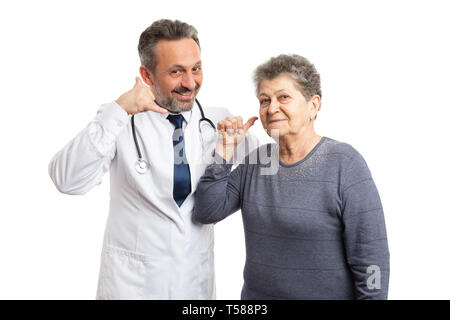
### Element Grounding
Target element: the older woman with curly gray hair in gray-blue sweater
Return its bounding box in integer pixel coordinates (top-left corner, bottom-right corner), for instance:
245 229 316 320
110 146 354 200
194 55 389 299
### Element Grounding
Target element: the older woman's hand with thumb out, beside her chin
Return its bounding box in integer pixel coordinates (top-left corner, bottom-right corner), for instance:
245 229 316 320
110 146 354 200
216 116 258 162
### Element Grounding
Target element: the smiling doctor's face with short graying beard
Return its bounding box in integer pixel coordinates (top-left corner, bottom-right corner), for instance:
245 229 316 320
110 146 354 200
151 38 203 113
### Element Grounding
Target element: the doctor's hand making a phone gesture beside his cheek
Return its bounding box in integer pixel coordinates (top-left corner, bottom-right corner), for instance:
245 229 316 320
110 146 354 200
116 77 167 114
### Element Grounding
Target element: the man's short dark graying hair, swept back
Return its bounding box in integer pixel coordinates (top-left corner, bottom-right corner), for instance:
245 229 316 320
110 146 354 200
138 19 200 72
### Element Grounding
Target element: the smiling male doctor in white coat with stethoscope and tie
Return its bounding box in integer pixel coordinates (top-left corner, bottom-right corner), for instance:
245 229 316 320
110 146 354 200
49 20 257 299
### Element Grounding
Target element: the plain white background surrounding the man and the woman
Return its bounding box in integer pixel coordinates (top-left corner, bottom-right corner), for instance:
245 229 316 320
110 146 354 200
0 0 450 299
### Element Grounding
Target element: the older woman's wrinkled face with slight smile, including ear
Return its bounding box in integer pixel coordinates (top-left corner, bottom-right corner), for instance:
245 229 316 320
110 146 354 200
258 74 320 137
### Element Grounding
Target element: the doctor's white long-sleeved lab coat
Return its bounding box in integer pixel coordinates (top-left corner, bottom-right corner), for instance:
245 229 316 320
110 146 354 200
49 102 257 299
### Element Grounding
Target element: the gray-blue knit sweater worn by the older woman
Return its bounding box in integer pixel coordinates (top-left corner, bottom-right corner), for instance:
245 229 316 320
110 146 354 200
194 137 389 299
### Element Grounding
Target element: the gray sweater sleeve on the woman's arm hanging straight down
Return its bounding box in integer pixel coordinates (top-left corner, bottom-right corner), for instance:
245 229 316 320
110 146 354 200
341 153 389 299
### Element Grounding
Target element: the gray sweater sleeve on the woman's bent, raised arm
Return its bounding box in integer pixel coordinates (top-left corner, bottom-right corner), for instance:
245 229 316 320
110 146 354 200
193 154 244 224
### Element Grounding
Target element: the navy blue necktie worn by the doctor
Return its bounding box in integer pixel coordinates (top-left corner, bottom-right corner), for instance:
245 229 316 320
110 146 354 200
167 114 191 207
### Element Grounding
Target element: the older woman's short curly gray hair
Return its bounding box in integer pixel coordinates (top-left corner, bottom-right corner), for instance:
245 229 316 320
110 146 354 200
253 54 322 100
